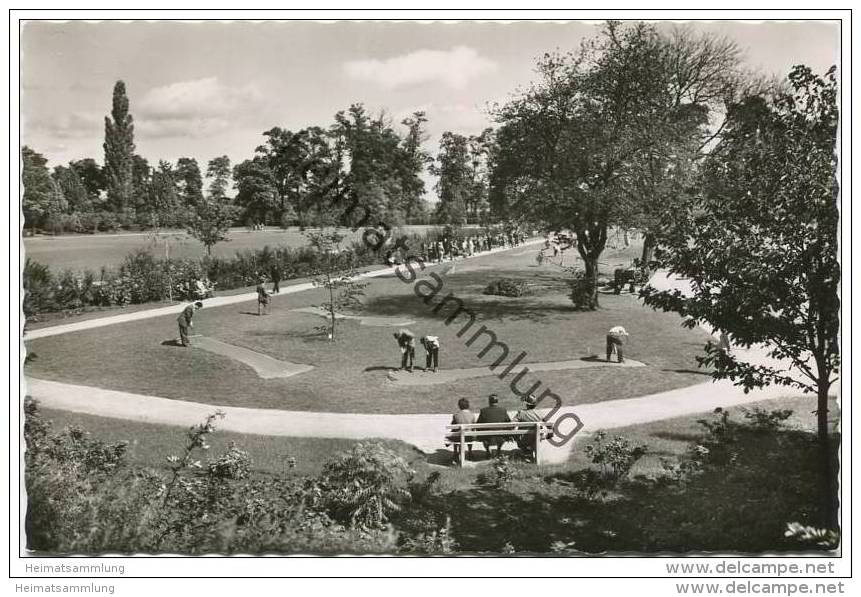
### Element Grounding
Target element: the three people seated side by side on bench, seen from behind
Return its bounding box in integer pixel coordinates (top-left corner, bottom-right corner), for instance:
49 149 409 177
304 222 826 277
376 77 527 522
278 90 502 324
451 394 543 460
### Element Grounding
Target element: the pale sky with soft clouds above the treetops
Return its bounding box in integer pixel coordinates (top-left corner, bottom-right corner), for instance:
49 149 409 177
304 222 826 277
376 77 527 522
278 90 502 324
21 21 840 196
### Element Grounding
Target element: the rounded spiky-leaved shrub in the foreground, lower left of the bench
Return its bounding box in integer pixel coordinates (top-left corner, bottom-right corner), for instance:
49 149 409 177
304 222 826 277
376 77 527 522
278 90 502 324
321 443 413 529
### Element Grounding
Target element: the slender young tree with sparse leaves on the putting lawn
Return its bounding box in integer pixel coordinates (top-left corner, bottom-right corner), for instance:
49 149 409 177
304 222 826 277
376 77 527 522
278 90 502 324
305 228 367 342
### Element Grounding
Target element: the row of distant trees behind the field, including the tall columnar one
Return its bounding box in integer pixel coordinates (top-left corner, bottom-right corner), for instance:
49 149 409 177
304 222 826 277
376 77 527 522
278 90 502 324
22 81 489 237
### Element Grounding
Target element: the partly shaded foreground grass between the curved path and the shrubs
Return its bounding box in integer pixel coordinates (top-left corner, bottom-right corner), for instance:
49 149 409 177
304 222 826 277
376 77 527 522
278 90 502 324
31 397 838 553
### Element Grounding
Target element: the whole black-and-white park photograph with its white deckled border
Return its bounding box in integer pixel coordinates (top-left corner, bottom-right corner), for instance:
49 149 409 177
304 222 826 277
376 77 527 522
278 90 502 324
10 11 850 594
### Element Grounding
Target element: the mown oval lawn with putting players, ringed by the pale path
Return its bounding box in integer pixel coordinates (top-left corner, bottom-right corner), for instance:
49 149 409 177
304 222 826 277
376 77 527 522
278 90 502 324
26 242 708 413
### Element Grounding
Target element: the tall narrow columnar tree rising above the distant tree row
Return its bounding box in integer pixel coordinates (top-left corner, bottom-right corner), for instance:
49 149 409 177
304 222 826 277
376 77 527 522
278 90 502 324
104 81 135 211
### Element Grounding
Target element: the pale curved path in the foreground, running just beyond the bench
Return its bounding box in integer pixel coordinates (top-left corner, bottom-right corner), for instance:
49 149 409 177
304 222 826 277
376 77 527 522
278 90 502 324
21 378 791 463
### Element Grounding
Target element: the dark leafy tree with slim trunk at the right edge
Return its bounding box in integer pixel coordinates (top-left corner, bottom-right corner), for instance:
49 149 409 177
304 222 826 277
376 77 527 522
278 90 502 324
642 66 840 525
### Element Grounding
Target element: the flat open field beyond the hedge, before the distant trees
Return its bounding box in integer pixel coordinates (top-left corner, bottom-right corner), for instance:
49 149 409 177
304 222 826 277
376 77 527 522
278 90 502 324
24 226 450 271
